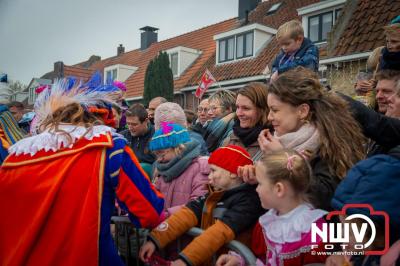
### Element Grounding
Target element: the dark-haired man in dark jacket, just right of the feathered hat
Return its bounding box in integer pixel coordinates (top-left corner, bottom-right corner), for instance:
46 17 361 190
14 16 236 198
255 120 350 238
121 104 156 164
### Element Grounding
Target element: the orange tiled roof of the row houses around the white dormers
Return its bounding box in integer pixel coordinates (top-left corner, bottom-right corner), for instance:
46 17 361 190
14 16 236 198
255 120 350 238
61 0 319 97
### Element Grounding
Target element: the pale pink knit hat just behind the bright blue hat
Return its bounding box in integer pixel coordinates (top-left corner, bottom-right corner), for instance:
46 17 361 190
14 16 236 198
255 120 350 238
154 102 187 130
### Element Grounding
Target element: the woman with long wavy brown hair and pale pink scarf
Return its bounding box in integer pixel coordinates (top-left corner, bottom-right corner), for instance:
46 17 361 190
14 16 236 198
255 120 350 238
259 67 365 209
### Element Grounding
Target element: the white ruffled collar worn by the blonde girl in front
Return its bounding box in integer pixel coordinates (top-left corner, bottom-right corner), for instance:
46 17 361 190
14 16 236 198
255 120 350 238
259 204 327 244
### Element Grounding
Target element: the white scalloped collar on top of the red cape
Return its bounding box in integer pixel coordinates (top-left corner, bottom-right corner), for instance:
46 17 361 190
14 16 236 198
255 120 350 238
8 124 115 156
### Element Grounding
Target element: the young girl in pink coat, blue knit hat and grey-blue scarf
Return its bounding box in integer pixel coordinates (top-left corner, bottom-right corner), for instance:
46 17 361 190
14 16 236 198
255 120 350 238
149 122 210 217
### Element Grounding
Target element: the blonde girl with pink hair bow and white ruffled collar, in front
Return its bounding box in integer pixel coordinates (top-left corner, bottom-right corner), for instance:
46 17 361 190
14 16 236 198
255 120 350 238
217 150 326 266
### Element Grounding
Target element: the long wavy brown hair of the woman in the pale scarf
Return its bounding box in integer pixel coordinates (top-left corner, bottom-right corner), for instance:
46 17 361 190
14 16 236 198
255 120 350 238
268 67 365 178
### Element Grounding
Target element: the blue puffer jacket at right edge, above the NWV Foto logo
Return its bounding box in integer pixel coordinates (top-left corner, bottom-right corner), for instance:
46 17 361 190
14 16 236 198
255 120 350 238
332 146 400 243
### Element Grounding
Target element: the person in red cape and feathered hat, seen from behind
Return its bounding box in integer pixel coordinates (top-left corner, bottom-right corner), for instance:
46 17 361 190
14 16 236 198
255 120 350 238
0 77 163 265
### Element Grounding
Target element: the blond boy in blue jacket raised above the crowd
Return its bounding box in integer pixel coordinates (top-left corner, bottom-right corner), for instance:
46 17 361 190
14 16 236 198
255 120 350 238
271 20 319 81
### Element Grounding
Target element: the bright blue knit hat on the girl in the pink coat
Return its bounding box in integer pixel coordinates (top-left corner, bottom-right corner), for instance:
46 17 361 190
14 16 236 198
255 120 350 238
149 122 190 151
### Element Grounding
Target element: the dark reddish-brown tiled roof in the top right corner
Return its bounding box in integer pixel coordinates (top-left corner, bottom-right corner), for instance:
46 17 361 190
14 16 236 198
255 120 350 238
333 0 400 56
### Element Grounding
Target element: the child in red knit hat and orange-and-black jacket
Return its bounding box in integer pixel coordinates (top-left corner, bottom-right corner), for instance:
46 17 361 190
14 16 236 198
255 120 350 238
140 145 264 265
